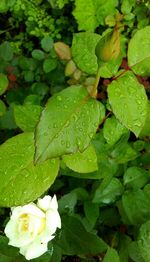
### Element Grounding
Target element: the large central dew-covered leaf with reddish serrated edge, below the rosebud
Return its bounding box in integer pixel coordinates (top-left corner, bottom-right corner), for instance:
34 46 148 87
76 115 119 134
35 86 104 162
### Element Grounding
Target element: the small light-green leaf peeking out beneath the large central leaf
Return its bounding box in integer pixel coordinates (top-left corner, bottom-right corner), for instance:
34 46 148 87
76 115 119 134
63 145 98 173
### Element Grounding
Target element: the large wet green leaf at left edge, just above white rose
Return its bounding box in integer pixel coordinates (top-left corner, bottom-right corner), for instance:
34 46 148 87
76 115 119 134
0 133 59 207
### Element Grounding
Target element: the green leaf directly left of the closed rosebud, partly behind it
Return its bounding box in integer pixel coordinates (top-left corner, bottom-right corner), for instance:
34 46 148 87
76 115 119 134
71 32 100 74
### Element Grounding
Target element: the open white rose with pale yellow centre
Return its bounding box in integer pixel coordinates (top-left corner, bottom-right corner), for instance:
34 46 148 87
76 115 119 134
4 196 61 260
